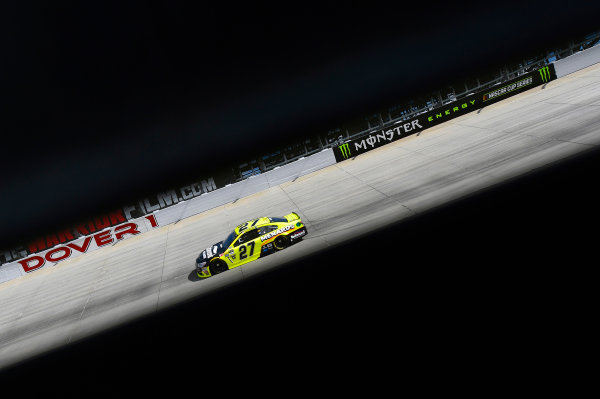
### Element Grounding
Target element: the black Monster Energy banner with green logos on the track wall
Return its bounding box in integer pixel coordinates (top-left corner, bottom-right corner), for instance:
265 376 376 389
333 64 556 162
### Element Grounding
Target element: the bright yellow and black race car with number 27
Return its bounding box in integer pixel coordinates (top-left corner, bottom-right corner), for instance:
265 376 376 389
196 212 308 278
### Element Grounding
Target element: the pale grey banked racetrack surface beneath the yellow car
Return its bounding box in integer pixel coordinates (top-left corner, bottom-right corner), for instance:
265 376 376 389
0 64 600 368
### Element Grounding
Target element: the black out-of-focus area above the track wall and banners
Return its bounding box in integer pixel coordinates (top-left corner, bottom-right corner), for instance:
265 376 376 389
0 1 597 250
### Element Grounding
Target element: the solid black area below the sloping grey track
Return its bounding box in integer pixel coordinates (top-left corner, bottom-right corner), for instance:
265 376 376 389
1 142 600 392
